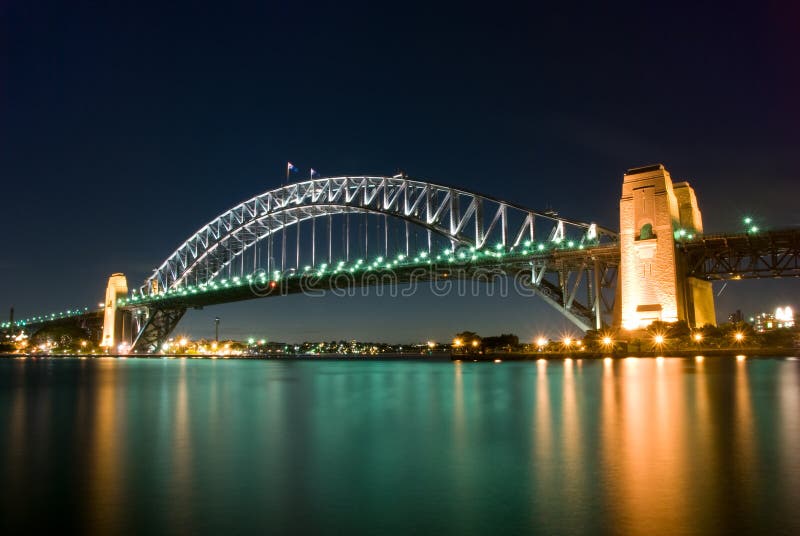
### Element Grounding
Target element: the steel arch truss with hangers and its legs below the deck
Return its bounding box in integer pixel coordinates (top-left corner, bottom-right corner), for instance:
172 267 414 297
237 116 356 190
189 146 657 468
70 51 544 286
128 175 618 352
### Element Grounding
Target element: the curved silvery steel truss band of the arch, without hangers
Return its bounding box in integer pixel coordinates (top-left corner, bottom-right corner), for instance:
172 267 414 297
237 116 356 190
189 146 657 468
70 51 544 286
140 175 617 295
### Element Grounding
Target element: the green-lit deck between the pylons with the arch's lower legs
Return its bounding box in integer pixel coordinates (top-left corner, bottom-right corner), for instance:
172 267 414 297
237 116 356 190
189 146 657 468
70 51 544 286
118 244 619 352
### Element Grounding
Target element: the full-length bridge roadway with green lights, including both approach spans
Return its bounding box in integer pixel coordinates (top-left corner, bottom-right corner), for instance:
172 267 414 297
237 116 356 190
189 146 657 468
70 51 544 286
0 228 800 344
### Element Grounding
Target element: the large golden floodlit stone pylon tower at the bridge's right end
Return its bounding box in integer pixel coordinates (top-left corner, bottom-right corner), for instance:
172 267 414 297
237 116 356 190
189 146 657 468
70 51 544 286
618 164 716 329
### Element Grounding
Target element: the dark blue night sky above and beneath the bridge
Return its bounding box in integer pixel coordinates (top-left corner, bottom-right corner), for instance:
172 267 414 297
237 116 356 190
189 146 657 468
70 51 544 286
0 0 800 342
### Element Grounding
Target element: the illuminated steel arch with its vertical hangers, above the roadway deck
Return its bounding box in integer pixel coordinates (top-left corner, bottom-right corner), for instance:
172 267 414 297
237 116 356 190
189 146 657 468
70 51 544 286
144 175 616 296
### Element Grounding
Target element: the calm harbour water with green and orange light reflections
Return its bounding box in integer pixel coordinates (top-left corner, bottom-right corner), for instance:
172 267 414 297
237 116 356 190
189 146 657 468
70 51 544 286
0 358 800 534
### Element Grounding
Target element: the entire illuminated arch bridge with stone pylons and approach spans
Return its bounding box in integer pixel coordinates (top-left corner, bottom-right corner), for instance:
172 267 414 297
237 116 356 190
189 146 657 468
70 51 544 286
6 165 800 353
